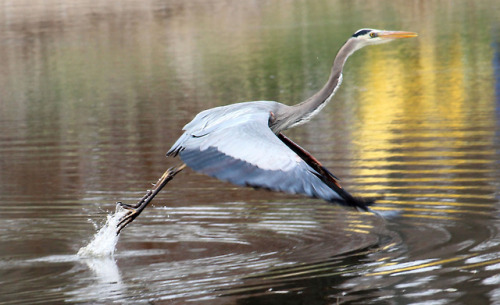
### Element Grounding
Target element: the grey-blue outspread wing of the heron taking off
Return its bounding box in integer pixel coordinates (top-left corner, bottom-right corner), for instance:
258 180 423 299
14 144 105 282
167 103 344 204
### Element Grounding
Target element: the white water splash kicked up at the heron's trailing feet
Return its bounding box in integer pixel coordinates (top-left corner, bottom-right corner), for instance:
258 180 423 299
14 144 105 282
78 205 127 257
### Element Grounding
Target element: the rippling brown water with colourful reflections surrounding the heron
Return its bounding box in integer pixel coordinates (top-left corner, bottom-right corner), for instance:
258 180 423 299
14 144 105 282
0 0 500 304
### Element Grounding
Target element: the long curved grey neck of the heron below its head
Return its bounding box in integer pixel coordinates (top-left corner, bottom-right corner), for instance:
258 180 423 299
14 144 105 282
273 39 359 132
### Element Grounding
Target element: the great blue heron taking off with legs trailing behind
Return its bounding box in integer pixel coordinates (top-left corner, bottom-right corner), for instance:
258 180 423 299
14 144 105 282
115 29 417 232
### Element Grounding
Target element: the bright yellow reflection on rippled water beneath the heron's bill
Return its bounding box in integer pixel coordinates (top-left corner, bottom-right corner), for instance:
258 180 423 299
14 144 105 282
353 19 496 219
